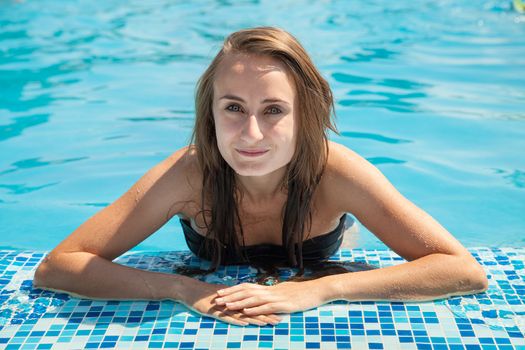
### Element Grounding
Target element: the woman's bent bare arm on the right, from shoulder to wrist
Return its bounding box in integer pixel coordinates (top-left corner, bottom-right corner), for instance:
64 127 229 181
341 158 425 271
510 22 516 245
319 143 488 300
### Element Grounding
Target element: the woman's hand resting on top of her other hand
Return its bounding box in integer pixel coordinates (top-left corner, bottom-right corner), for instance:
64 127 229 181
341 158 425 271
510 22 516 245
215 280 324 315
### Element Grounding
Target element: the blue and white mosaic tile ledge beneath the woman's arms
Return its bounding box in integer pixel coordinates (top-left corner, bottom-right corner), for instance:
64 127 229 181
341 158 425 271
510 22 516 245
0 248 525 349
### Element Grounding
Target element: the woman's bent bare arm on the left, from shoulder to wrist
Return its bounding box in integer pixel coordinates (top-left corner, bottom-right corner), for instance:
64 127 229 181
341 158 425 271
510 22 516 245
33 149 191 299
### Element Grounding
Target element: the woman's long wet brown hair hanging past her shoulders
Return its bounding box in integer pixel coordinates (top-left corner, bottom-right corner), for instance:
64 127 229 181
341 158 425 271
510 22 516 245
190 27 337 271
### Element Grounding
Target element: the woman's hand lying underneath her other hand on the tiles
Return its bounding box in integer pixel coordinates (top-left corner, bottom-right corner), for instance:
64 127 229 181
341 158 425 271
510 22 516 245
179 279 281 326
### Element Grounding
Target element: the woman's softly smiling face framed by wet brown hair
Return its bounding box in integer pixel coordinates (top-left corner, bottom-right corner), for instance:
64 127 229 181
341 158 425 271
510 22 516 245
213 54 297 176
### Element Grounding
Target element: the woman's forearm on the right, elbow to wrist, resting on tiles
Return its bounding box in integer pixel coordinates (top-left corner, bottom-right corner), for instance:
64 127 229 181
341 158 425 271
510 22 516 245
318 254 488 302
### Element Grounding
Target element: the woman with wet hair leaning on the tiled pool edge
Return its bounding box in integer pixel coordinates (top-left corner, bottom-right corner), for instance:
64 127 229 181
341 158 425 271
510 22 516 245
34 27 487 325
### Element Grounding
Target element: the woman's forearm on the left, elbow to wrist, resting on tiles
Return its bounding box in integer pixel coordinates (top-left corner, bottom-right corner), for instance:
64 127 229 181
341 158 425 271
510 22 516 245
33 252 193 300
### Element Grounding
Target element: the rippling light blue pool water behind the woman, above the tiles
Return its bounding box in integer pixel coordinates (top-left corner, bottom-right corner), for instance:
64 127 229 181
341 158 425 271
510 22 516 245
0 0 525 250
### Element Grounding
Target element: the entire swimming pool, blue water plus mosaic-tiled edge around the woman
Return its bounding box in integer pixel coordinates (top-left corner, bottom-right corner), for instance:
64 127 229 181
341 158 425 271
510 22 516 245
0 0 525 349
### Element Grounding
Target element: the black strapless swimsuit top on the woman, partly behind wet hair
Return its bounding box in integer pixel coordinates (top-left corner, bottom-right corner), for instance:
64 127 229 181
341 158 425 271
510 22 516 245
180 214 353 265
